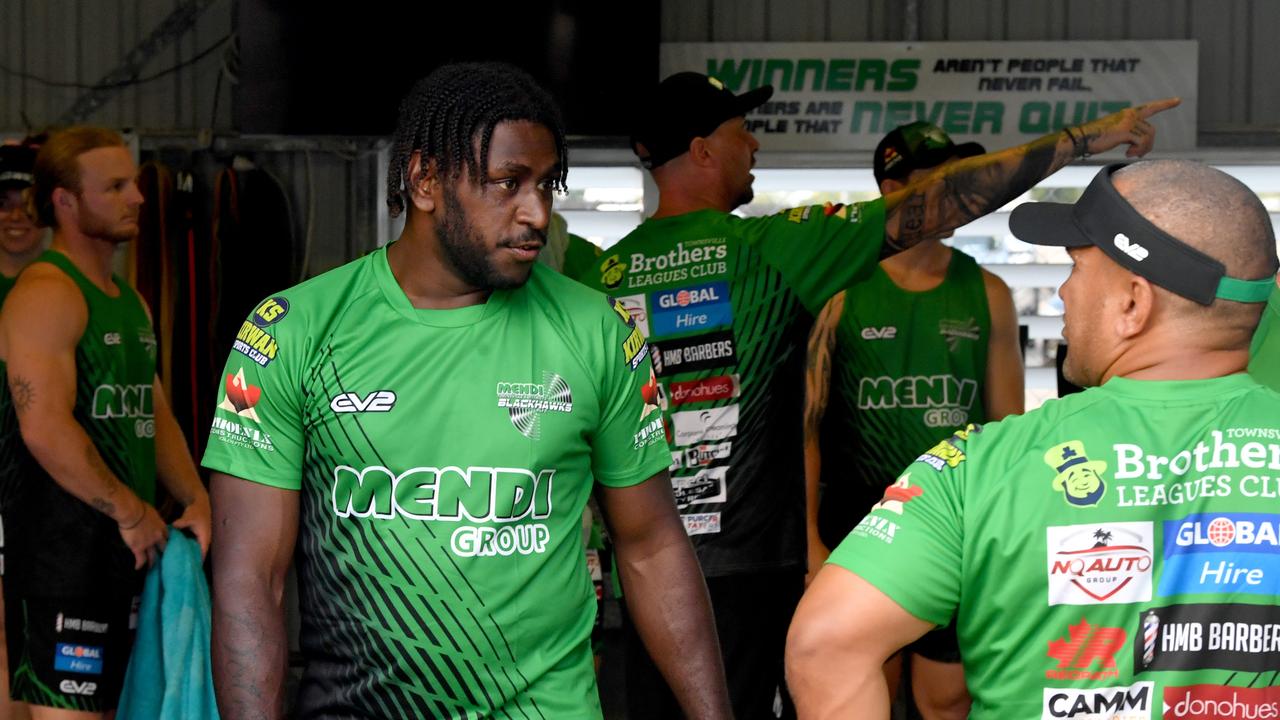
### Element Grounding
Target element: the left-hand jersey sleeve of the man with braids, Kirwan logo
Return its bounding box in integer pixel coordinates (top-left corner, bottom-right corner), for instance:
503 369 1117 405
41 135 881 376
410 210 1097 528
201 296 307 489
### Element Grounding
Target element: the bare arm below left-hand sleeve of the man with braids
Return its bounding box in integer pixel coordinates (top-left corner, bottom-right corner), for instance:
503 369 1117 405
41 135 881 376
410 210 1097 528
210 473 298 720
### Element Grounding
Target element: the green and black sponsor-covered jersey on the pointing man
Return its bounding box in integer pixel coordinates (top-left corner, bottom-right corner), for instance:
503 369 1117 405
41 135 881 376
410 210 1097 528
580 200 884 577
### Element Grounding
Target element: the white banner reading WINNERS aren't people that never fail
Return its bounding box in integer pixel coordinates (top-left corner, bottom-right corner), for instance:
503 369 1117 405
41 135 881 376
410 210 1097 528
660 40 1198 151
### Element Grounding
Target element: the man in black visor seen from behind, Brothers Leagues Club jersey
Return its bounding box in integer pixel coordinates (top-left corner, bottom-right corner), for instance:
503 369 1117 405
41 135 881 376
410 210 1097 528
787 160 1280 720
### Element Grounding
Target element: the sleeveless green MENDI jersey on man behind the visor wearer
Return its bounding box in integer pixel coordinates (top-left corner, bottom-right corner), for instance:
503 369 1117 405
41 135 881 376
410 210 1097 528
818 250 991 547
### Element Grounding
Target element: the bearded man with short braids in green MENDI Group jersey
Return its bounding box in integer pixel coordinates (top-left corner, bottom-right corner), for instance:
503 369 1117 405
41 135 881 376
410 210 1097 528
204 64 728 720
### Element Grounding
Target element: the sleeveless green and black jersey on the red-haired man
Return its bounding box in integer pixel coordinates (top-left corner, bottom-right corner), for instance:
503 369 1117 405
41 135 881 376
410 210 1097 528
0 250 156 597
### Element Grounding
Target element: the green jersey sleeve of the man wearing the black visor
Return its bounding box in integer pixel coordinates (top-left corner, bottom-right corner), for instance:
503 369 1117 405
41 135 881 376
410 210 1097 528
827 425 979 625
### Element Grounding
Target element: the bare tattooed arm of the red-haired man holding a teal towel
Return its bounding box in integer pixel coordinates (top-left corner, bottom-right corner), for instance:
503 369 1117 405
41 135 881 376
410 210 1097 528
0 264 168 568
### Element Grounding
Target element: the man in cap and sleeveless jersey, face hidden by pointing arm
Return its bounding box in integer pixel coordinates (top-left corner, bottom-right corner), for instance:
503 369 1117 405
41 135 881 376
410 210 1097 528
805 122 1023 720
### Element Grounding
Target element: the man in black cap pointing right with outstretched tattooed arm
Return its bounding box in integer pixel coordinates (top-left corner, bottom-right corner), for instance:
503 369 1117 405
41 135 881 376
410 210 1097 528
581 73 1176 720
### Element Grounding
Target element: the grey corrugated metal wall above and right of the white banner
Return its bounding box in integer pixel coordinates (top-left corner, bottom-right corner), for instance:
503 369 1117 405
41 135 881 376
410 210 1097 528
662 0 1280 134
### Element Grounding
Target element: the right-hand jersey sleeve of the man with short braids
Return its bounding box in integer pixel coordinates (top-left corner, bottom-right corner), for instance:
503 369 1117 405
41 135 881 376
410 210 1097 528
591 299 671 487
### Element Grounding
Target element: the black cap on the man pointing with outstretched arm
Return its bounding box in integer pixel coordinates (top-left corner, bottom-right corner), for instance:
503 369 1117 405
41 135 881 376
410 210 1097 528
631 72 773 169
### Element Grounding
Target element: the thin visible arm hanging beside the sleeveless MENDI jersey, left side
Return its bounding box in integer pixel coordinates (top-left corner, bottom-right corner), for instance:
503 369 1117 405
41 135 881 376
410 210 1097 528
804 291 845 585
